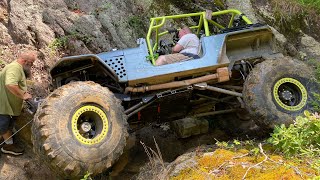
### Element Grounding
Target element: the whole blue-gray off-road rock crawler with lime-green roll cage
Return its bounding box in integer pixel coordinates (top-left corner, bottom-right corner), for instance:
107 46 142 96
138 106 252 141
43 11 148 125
32 9 317 178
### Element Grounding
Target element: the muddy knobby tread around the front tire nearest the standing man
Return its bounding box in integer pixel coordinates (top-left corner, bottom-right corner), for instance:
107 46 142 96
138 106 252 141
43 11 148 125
32 82 128 178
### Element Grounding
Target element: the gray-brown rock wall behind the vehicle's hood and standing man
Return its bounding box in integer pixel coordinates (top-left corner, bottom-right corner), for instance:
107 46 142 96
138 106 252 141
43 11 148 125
0 0 223 149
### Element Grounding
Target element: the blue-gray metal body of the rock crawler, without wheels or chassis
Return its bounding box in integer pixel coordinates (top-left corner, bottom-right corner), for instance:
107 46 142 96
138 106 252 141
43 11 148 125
51 10 276 87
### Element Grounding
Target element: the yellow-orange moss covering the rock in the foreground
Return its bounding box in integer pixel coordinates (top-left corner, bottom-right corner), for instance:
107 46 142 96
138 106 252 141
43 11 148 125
170 149 319 180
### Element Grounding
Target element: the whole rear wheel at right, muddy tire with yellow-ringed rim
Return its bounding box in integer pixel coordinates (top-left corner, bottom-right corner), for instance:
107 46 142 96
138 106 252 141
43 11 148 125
243 57 319 129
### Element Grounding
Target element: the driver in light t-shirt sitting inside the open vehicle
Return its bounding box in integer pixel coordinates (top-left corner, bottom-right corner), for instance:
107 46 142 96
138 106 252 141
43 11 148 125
156 27 200 66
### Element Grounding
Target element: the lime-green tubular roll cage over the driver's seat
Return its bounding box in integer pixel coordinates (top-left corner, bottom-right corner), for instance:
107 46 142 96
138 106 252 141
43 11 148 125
146 9 252 65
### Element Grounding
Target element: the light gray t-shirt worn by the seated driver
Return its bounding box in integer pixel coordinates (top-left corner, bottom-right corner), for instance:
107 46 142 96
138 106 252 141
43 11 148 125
178 34 200 55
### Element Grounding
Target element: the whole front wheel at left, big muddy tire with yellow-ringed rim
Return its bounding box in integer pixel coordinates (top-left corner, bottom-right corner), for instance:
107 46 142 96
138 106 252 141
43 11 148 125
32 81 128 179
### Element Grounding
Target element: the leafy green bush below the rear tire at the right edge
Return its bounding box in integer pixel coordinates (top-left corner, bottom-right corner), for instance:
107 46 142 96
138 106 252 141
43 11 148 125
268 111 320 157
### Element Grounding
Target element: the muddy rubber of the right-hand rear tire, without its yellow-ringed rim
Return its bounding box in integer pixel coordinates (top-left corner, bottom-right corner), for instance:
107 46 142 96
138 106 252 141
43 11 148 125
243 57 317 129
